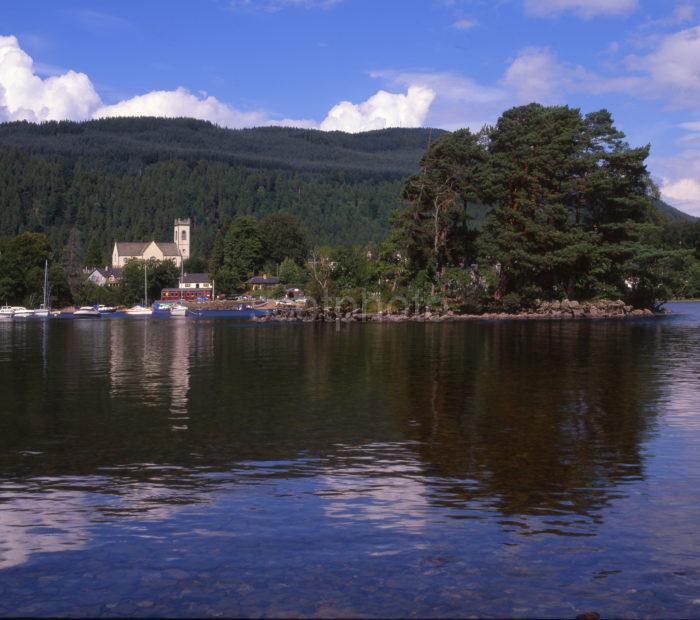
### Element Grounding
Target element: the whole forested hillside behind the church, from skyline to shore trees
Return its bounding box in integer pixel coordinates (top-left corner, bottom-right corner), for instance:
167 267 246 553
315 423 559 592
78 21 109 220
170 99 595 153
0 118 442 258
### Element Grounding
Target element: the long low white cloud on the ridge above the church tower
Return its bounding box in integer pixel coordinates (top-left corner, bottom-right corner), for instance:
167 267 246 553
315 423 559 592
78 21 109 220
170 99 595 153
93 87 267 127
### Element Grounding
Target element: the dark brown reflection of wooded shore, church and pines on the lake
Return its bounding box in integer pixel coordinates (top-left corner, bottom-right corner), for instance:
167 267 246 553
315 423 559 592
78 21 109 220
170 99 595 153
0 320 668 516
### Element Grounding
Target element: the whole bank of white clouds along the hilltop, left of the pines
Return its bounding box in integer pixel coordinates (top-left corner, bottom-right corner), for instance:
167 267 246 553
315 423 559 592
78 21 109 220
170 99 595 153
0 33 435 132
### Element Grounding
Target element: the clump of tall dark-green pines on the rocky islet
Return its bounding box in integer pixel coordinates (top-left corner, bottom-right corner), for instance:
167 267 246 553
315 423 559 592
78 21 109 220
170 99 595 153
395 104 696 310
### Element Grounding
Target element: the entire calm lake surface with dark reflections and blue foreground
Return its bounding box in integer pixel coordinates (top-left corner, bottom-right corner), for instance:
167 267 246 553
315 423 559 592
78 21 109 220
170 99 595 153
0 304 700 618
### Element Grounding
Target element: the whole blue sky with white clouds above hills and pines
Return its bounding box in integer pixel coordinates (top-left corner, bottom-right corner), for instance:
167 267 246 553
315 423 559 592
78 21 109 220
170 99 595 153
0 0 700 215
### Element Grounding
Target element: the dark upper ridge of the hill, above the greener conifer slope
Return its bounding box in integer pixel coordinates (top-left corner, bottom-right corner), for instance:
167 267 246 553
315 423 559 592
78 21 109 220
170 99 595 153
0 117 444 176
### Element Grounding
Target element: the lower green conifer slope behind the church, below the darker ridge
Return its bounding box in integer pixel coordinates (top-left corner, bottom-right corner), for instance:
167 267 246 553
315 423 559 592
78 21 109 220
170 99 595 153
0 151 401 260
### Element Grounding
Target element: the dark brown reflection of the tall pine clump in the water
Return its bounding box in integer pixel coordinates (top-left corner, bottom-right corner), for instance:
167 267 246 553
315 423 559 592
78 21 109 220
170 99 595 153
382 323 659 524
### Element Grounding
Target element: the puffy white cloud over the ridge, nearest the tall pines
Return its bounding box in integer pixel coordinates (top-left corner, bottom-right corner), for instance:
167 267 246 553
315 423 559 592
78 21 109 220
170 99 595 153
320 86 435 133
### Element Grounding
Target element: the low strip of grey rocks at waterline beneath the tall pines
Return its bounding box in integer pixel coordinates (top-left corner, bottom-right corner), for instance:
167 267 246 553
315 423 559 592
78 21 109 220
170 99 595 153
251 299 667 323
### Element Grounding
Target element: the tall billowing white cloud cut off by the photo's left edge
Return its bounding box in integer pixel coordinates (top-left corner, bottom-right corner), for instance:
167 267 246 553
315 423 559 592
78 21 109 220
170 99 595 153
0 36 100 122
